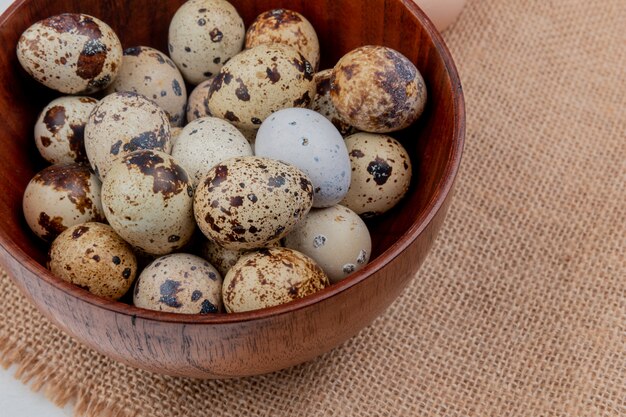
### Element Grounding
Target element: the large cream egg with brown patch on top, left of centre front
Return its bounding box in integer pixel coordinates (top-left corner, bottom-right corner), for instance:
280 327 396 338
102 150 195 255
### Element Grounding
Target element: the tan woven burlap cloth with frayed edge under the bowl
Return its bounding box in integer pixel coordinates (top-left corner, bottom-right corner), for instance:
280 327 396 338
0 0 626 417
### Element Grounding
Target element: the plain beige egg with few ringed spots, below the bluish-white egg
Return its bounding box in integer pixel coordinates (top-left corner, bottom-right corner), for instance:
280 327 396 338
284 205 372 283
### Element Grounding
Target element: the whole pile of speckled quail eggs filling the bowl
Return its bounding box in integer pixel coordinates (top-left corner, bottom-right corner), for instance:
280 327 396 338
17 0 426 314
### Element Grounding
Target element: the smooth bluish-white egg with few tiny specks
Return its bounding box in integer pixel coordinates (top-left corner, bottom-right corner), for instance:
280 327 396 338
255 108 350 207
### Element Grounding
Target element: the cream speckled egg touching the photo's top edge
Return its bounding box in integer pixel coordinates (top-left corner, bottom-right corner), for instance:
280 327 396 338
168 0 246 85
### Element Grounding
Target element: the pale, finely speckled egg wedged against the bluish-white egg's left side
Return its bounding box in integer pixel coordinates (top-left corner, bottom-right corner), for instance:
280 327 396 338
172 117 252 187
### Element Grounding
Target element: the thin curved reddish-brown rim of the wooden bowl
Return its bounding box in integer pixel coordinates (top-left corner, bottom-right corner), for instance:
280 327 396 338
0 0 465 325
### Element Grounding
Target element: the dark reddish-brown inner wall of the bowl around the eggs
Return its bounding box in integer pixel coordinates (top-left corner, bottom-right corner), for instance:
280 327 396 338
0 0 461 318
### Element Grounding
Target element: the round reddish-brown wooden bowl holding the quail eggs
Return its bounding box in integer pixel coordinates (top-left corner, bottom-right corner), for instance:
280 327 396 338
0 0 465 378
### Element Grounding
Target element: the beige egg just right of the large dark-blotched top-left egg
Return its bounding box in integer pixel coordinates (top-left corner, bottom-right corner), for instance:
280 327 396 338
107 46 187 126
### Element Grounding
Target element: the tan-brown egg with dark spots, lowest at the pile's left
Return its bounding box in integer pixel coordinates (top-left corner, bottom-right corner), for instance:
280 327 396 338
49 223 137 300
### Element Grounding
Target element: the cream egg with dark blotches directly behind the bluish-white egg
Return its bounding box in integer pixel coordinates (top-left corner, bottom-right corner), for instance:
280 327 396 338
209 45 315 130
